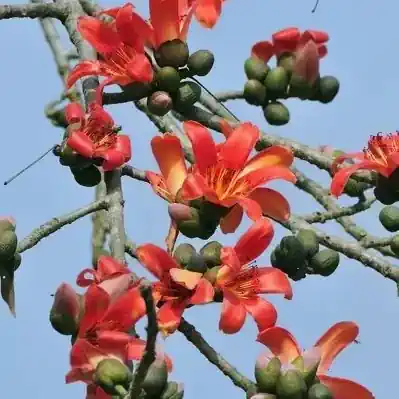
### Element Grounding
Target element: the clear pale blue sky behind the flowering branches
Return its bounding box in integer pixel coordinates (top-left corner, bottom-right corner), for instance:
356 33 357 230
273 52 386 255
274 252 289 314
0 0 399 399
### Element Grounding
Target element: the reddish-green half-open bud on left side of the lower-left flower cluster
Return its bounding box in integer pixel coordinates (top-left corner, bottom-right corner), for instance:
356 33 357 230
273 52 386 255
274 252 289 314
50 283 83 335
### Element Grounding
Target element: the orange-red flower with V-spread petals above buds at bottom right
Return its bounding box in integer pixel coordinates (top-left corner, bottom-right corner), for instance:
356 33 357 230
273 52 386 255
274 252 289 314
257 321 375 399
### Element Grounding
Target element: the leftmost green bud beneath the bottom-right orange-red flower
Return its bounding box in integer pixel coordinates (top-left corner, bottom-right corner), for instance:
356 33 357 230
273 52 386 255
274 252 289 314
255 356 281 393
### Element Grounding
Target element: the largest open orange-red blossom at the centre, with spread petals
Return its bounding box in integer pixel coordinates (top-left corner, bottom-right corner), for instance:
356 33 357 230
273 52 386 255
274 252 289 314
147 121 296 233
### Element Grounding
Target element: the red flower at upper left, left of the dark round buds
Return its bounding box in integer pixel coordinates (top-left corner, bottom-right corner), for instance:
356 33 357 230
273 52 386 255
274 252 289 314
67 3 153 100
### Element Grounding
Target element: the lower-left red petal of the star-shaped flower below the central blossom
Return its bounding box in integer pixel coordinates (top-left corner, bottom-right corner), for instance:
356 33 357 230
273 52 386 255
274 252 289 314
219 292 247 334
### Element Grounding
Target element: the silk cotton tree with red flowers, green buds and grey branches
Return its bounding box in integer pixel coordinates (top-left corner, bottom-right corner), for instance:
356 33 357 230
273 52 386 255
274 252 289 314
0 0 399 399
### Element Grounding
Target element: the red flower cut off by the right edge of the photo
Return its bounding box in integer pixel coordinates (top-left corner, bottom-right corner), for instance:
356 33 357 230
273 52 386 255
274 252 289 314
331 132 399 197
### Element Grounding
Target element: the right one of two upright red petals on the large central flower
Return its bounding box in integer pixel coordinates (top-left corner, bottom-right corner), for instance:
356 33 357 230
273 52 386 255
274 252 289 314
219 122 260 170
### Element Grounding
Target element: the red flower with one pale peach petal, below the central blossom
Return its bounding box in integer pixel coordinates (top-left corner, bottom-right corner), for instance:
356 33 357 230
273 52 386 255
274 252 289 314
137 244 214 335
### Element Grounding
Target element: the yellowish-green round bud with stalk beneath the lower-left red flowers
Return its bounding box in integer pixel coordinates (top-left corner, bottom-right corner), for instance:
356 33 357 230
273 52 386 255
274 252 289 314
93 359 132 395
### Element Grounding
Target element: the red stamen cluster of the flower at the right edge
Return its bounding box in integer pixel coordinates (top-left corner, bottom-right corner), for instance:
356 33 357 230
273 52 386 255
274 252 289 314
363 132 399 166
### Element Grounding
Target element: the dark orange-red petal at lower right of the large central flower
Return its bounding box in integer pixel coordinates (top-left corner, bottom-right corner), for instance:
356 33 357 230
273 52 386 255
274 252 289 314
250 187 291 221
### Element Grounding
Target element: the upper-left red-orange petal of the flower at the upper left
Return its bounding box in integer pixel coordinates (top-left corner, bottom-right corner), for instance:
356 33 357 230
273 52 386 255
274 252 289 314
78 16 122 53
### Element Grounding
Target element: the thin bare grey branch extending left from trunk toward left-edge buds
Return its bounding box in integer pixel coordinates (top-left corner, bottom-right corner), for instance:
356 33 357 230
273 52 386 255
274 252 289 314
17 198 109 253
